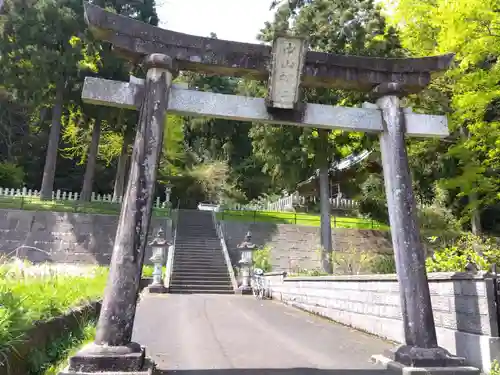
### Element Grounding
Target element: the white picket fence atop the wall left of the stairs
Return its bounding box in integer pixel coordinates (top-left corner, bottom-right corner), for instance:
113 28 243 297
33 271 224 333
0 187 167 208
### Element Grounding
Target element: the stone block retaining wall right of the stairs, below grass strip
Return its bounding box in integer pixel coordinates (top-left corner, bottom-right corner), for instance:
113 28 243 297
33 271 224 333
221 221 392 271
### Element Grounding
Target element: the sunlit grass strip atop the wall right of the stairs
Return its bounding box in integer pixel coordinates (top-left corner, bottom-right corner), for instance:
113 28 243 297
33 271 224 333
217 211 389 230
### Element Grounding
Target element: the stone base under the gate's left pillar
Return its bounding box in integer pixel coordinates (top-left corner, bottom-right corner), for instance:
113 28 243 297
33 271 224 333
59 343 155 375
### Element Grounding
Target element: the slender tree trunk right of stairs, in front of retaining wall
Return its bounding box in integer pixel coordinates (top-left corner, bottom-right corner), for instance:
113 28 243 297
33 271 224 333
317 130 333 273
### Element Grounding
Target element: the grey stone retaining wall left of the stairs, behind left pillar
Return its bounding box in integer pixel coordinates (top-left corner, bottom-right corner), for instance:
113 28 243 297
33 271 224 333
0 210 171 265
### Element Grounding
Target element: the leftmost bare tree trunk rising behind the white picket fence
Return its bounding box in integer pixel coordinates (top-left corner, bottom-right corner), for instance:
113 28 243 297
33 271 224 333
40 81 65 200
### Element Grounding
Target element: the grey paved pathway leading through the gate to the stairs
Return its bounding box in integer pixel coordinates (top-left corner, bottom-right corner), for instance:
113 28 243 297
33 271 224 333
134 294 393 375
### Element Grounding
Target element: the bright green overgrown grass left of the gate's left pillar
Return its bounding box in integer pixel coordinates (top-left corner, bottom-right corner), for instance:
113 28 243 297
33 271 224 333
0 263 108 357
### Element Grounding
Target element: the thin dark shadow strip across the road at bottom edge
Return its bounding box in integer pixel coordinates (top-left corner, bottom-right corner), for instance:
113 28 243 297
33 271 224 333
155 367 394 375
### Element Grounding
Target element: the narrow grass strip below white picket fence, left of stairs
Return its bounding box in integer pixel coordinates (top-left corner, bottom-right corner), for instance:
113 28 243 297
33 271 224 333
0 197 170 217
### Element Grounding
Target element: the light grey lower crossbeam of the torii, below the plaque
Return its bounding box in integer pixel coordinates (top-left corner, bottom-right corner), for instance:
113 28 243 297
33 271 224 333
82 77 449 137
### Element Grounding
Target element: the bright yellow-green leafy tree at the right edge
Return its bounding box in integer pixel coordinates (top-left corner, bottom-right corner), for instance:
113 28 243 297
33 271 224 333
393 0 500 233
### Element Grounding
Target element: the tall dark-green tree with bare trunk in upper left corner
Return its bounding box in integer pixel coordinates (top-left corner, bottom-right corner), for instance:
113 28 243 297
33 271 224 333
0 0 95 199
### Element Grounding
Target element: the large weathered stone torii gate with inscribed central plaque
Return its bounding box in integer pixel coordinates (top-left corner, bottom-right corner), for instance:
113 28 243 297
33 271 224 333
64 3 476 374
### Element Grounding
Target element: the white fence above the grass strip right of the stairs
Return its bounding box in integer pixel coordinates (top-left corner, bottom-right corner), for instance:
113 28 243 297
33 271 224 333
226 192 358 212
